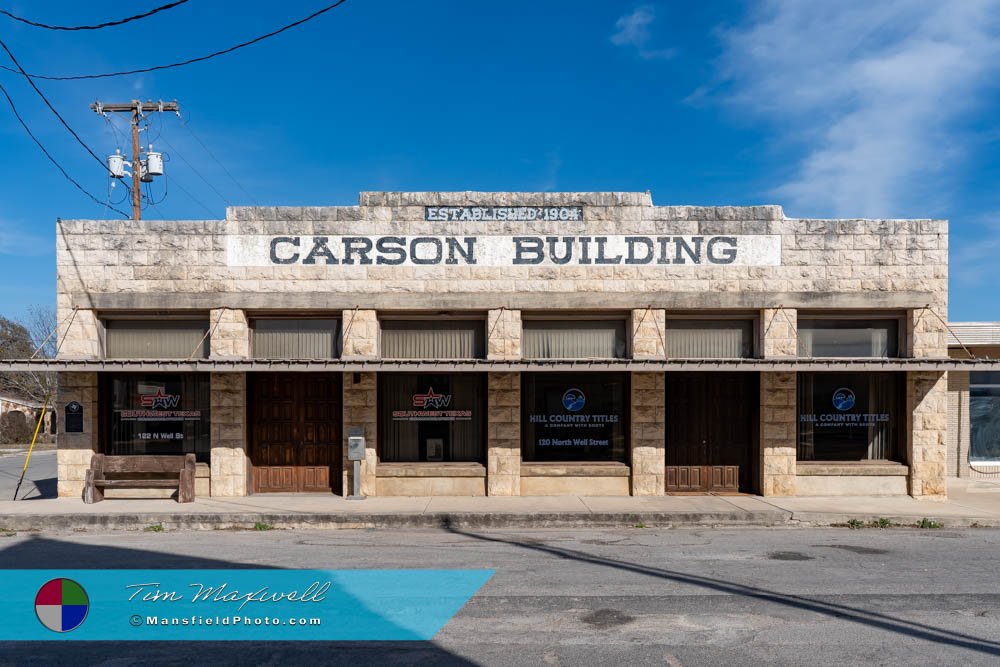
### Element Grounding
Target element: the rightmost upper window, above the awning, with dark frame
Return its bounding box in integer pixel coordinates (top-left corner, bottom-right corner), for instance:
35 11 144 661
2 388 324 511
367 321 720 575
798 318 899 357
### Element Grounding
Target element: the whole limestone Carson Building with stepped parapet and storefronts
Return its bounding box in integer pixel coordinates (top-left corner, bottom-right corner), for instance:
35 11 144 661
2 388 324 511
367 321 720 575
37 192 992 499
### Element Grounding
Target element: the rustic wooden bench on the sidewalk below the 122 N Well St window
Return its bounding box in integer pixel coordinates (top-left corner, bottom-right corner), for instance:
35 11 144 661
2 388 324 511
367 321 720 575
83 454 195 503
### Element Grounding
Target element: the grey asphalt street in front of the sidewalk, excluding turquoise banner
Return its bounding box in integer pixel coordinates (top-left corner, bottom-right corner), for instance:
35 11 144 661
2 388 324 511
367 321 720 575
0 528 1000 666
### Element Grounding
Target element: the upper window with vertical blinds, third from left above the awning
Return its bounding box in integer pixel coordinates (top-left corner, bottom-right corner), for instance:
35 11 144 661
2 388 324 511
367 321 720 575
381 320 486 359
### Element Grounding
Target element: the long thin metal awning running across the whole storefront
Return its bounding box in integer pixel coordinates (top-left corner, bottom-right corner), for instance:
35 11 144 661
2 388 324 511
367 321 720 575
0 358 1000 373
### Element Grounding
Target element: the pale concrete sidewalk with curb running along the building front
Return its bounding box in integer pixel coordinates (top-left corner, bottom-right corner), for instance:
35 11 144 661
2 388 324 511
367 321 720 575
0 480 1000 531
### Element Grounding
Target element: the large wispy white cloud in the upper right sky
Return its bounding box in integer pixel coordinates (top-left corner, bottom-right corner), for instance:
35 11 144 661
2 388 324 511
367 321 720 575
709 0 1000 216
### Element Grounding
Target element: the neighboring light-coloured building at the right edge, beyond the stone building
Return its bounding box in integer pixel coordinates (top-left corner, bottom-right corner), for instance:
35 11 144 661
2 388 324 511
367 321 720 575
948 322 1000 477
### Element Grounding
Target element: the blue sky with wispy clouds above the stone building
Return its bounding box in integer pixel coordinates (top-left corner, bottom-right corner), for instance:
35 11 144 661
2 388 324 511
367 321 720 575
0 0 1000 321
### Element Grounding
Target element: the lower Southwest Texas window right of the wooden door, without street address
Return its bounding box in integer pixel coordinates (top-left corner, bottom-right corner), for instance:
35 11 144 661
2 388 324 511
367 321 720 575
378 373 486 463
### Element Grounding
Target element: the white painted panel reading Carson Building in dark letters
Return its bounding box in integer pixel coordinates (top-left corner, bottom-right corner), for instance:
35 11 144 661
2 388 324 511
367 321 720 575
226 234 781 267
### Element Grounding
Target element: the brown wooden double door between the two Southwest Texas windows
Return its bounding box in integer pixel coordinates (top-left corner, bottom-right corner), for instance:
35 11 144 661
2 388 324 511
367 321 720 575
247 373 343 493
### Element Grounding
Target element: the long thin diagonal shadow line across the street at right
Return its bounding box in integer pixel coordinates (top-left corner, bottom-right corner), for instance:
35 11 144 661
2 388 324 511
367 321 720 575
447 526 1000 655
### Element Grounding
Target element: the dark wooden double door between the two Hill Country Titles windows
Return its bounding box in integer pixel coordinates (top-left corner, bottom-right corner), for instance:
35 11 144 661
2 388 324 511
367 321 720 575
666 373 760 493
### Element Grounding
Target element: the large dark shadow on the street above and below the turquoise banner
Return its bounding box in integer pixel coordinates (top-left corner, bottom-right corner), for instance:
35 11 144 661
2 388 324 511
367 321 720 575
0 536 475 667
